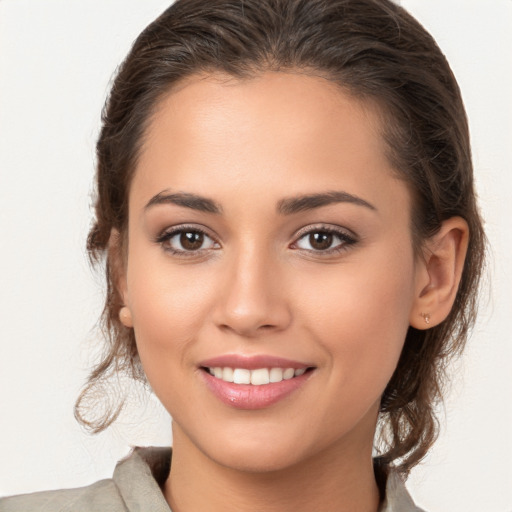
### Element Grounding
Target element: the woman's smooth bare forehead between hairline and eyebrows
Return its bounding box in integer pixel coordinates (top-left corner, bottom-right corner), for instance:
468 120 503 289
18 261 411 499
130 68 408 220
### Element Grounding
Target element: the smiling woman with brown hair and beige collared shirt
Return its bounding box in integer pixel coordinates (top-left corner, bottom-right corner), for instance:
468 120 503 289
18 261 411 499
2 0 484 512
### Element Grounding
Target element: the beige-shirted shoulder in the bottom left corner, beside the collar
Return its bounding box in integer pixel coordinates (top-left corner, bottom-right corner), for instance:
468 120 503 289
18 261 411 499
0 480 127 512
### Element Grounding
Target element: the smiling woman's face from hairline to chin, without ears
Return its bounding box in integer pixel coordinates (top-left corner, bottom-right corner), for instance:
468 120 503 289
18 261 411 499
120 73 419 471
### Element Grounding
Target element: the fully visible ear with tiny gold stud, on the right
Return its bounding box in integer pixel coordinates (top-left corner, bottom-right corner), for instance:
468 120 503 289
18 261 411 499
409 217 469 329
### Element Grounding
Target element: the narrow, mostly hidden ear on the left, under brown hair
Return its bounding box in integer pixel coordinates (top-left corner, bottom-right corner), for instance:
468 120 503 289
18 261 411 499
108 228 133 328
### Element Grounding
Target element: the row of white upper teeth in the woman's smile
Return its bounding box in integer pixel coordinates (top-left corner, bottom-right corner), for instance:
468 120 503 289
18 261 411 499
206 366 307 386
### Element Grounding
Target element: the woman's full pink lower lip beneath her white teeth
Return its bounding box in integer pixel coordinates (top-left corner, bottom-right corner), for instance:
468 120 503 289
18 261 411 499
201 370 312 410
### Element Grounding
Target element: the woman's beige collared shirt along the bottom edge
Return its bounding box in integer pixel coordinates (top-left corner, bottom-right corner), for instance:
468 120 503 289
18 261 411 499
0 448 423 512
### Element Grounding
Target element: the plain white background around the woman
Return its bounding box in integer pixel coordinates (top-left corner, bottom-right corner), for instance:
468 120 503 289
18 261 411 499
0 0 512 512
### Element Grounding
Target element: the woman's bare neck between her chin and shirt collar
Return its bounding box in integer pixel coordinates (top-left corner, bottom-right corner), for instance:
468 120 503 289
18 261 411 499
164 426 379 512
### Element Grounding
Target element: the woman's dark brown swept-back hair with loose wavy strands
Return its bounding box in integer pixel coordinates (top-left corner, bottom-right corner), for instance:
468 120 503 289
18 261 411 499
75 0 485 473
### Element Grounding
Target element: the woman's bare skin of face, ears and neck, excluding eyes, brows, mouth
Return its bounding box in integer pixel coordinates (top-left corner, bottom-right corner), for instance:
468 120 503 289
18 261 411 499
113 72 467 512
